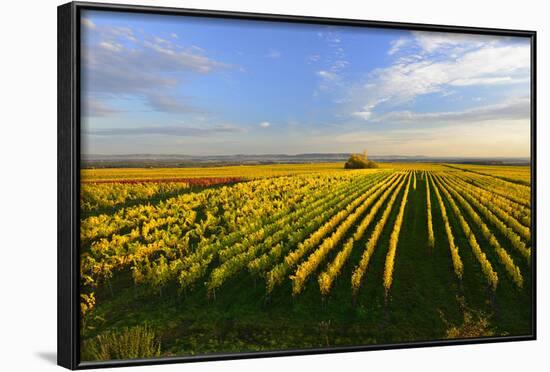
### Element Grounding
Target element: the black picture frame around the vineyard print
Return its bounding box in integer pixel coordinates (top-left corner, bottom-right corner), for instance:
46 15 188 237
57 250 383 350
57 2 537 369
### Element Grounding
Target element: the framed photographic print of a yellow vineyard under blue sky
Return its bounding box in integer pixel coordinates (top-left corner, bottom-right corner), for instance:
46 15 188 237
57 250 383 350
58 3 536 369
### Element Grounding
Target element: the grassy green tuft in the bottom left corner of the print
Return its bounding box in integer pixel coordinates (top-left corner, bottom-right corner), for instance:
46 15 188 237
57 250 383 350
82 325 160 361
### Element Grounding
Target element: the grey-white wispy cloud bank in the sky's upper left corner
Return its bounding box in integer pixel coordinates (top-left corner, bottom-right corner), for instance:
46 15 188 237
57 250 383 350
82 18 231 114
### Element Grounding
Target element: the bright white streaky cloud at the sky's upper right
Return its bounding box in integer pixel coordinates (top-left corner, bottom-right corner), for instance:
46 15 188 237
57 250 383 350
350 36 530 118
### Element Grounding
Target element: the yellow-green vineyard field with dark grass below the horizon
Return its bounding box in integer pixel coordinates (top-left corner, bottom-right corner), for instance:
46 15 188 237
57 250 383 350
80 163 532 355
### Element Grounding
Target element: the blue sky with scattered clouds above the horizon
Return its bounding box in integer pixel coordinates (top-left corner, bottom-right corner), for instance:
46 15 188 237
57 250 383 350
81 11 530 157
